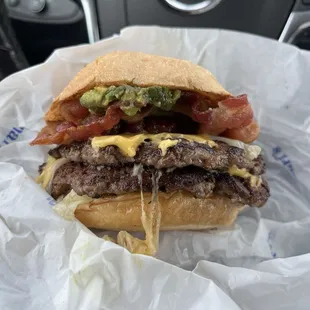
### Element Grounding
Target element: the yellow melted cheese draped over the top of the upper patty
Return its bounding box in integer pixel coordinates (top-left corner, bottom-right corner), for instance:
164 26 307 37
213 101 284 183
91 133 217 157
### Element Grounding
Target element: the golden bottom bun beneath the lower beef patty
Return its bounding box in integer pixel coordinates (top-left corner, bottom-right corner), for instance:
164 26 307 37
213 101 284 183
75 191 243 231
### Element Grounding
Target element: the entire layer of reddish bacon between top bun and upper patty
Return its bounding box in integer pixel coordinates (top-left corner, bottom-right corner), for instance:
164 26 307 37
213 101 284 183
31 92 259 145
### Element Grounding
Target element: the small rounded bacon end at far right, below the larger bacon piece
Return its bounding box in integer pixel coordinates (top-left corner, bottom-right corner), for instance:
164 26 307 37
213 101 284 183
222 119 260 143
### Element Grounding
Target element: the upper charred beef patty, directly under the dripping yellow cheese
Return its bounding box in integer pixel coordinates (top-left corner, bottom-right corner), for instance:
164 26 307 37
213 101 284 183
49 140 265 175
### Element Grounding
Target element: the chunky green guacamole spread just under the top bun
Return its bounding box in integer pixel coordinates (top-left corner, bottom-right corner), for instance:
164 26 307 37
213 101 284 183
80 85 181 116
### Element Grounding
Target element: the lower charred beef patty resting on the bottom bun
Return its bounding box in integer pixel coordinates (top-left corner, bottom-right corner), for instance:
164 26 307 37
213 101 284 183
52 162 269 207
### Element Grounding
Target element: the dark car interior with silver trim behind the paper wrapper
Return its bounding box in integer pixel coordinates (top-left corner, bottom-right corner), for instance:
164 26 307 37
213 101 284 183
0 0 310 80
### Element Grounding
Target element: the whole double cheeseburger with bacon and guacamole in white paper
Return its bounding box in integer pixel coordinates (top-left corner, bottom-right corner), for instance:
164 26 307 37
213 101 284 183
31 51 269 255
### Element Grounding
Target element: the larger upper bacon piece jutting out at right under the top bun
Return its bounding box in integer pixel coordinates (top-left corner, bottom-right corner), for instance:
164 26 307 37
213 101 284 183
196 95 253 135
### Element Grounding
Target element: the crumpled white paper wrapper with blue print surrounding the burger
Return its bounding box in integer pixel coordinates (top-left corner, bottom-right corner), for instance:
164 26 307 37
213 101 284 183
0 27 310 310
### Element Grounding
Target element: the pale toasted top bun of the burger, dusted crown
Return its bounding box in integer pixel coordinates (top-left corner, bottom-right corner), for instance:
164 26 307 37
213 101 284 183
45 51 230 121
